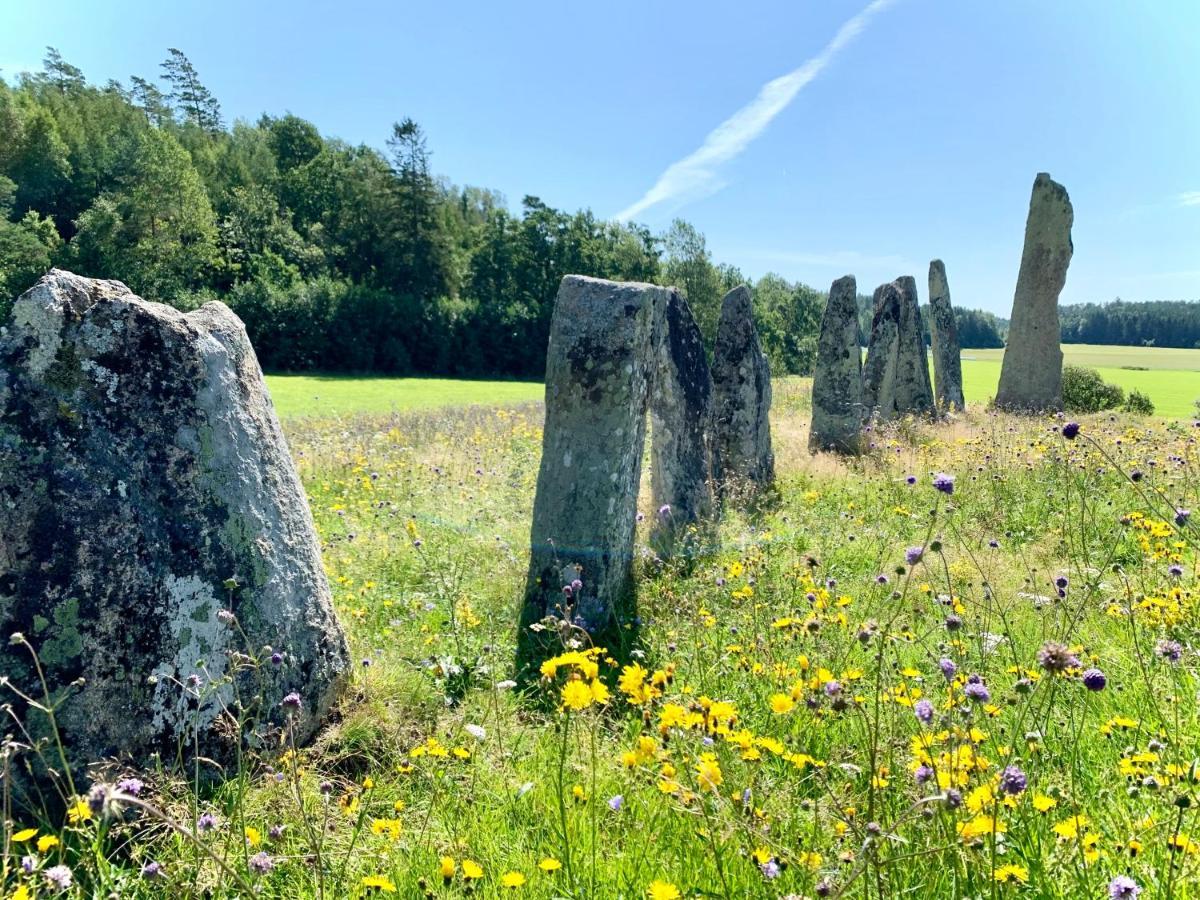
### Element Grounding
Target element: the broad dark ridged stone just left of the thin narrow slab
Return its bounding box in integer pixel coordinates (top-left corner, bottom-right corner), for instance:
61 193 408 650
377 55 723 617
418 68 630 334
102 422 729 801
863 275 935 422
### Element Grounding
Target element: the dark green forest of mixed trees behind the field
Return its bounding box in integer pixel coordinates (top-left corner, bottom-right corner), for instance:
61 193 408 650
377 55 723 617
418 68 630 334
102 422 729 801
0 48 1180 378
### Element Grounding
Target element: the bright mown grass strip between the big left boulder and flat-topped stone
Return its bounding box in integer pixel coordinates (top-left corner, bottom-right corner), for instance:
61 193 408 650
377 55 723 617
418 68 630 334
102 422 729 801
266 374 544 419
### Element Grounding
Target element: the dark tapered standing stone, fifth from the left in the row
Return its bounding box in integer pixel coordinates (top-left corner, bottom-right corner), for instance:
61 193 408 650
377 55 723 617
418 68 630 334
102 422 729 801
809 275 864 454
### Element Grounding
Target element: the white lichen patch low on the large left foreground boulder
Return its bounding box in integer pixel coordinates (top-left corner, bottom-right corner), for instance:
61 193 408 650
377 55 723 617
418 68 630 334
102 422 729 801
151 575 232 738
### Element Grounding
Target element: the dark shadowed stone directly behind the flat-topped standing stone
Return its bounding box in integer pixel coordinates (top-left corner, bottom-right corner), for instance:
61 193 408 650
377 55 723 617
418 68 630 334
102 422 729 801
649 288 713 557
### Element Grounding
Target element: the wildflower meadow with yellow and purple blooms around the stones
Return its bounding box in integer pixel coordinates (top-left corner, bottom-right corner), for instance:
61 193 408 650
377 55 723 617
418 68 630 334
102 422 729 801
7 364 1200 900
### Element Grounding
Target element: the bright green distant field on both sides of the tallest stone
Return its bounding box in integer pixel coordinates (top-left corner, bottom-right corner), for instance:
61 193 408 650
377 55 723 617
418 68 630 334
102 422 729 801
962 343 1200 419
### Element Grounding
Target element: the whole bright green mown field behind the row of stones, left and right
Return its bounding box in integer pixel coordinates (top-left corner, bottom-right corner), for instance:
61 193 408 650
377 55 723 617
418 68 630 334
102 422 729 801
268 344 1200 419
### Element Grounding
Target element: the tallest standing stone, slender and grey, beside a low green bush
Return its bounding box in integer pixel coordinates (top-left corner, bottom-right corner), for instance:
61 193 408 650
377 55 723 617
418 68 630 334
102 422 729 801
996 172 1075 412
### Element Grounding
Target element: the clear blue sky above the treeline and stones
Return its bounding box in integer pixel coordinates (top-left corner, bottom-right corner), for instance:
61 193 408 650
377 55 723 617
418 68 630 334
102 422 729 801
0 0 1200 314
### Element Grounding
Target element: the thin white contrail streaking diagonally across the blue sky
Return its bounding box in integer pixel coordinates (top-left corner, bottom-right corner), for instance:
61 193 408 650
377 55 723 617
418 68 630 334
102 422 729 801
617 0 893 222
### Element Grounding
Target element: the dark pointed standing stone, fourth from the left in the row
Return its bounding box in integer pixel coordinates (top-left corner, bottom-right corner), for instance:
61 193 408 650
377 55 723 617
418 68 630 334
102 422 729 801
713 284 775 487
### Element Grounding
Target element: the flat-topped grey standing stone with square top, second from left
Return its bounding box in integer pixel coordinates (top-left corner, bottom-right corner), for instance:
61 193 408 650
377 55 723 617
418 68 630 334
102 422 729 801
518 275 672 680
